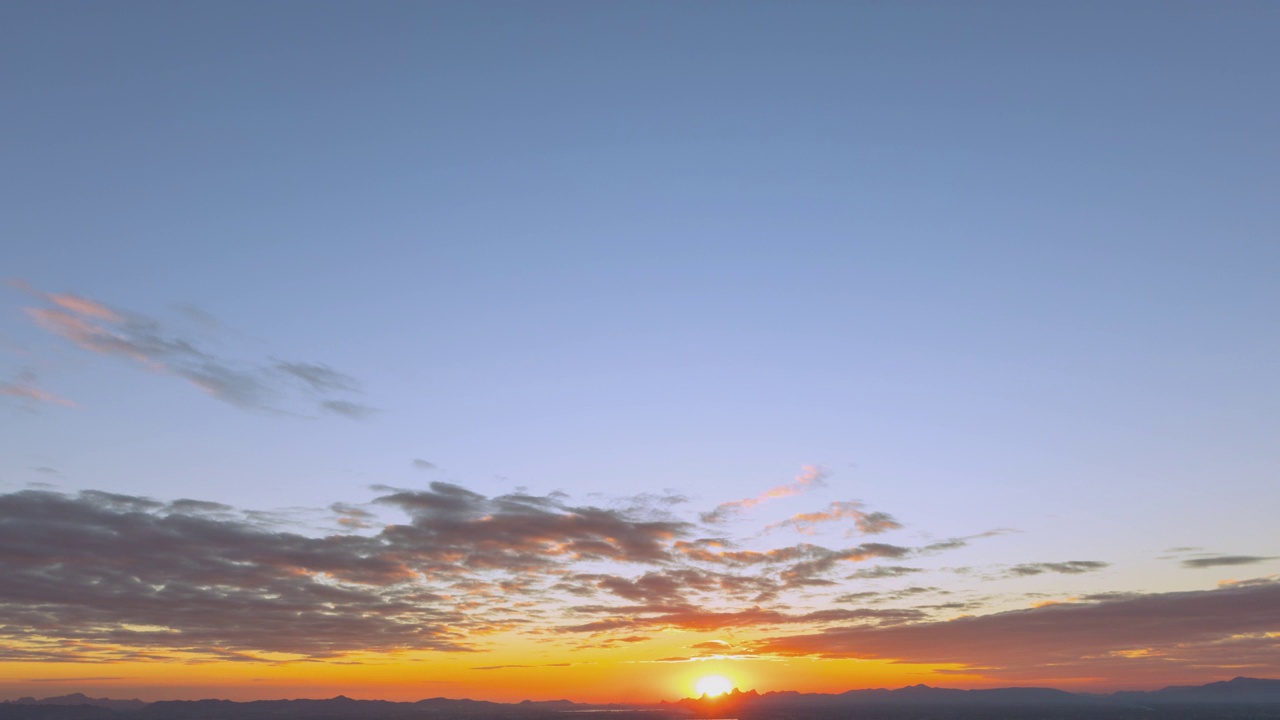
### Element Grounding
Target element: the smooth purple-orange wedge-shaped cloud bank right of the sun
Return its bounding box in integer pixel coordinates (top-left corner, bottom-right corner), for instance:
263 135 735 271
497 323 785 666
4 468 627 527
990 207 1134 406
753 582 1280 676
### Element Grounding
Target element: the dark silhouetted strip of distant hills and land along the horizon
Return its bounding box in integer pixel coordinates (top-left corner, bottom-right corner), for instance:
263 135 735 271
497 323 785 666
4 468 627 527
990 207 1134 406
10 678 1280 720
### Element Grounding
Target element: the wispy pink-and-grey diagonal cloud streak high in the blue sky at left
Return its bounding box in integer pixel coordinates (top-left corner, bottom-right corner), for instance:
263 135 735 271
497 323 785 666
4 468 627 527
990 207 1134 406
18 282 375 419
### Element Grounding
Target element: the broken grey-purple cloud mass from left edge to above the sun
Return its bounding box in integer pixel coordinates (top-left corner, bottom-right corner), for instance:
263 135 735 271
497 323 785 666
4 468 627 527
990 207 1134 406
0 482 1141 662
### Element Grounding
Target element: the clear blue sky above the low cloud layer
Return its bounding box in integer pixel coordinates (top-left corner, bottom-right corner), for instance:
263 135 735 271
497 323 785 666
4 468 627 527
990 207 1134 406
0 3 1280 696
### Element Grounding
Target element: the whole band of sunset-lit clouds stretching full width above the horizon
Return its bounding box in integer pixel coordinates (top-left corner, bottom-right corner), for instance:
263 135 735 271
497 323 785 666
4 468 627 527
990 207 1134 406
0 482 1280 678
